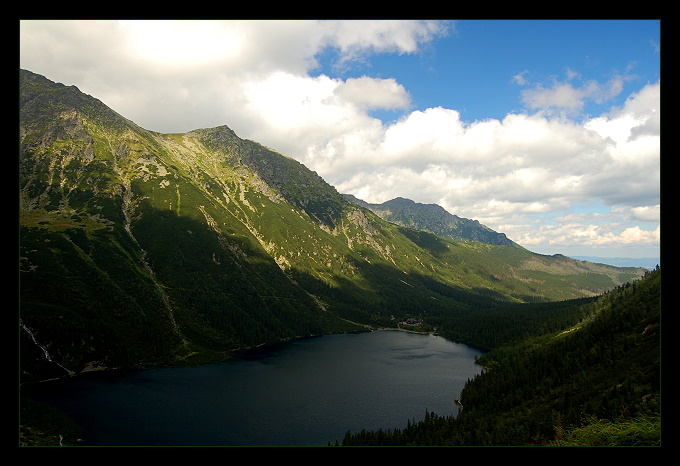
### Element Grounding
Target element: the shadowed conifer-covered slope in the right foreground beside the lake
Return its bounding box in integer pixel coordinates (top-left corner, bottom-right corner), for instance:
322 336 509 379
342 268 661 446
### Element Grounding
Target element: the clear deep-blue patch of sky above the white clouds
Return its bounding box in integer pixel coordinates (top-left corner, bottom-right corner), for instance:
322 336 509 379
316 20 660 122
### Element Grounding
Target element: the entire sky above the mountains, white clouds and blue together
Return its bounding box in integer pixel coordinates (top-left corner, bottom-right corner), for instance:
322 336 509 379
20 20 661 257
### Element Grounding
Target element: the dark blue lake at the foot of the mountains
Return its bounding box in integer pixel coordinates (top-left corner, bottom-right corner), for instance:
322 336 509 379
25 331 481 446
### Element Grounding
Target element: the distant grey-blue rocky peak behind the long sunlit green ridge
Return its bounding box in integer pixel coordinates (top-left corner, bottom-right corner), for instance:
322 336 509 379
345 194 518 246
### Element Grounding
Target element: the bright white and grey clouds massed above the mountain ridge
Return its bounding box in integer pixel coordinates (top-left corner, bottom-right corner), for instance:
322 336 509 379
20 21 660 255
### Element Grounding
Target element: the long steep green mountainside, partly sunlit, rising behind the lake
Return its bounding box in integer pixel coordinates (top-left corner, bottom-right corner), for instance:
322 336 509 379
19 70 643 378
